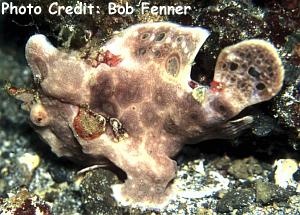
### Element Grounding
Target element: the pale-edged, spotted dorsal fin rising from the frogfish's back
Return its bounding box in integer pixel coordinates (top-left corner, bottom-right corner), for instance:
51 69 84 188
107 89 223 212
104 22 209 89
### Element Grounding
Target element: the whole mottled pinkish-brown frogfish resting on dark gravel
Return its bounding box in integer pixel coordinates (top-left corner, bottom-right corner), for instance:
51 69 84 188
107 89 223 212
7 23 284 207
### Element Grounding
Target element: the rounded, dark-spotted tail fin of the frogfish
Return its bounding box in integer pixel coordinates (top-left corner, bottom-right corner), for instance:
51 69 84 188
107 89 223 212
214 39 284 114
